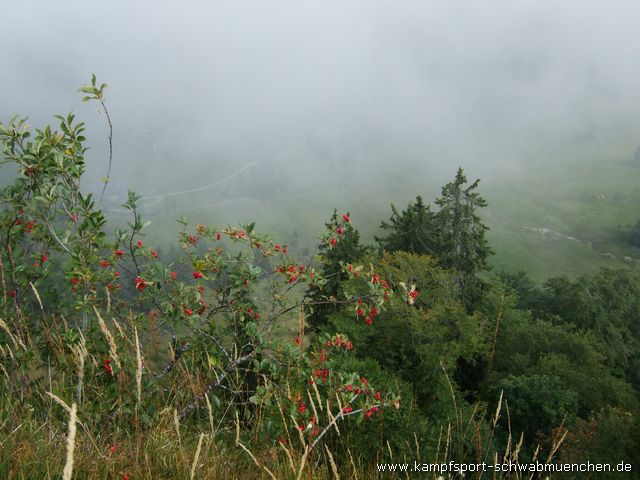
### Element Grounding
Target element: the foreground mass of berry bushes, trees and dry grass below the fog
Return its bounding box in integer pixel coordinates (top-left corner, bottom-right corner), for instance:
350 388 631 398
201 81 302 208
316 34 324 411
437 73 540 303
0 77 640 480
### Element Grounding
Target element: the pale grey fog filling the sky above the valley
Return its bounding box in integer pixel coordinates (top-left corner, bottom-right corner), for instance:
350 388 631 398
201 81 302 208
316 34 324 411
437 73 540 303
0 0 640 232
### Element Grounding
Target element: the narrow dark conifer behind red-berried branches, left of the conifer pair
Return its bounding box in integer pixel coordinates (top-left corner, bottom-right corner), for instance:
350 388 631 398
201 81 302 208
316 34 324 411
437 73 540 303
306 209 369 329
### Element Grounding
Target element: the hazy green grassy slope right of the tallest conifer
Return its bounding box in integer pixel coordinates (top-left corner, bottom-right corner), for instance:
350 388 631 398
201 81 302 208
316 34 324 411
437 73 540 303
486 154 640 281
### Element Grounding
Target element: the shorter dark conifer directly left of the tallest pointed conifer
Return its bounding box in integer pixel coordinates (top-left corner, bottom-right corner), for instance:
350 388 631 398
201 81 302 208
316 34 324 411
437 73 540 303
374 195 437 255
